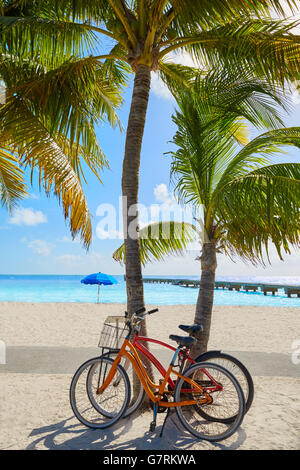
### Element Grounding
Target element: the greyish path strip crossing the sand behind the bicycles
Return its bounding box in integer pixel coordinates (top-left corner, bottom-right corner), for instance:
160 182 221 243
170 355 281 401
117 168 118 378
0 346 300 378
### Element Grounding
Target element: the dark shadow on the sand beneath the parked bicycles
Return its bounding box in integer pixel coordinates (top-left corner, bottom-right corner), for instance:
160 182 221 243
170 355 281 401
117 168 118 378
27 412 246 450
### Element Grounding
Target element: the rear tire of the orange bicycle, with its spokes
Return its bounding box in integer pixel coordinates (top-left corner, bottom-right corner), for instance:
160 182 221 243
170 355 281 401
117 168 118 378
174 362 245 442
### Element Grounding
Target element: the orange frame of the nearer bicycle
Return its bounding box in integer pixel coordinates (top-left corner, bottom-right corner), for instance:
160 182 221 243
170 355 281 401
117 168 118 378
97 338 212 408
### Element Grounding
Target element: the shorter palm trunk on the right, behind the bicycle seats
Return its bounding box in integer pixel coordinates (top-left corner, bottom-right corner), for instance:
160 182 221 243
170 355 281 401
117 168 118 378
191 240 217 357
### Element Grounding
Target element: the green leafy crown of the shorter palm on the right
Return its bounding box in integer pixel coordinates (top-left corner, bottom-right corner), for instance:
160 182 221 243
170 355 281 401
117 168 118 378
170 75 300 263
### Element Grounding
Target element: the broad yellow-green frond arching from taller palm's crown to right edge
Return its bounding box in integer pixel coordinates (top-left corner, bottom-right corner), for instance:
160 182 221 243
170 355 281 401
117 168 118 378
160 16 300 86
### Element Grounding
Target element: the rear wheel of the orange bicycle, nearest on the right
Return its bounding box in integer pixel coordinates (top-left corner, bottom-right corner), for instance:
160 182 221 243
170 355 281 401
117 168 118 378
174 362 245 442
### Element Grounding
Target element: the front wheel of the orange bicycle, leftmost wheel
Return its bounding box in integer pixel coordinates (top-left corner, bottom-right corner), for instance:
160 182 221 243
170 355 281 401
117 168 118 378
69 357 130 429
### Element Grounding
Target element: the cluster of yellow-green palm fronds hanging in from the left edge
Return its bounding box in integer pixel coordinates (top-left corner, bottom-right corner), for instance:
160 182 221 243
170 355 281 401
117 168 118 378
0 48 124 247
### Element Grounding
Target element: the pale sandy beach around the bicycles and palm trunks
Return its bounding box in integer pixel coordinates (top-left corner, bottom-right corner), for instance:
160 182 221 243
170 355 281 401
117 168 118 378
0 302 300 450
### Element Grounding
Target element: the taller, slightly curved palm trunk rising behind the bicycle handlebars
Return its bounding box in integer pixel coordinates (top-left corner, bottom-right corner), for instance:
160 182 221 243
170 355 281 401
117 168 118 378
122 64 153 390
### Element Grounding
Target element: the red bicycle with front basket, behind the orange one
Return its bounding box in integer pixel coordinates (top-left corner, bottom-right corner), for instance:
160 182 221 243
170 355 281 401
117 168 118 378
87 308 254 422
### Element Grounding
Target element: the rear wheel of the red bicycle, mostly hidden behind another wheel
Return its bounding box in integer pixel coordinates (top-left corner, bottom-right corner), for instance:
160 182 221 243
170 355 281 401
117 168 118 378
195 351 254 413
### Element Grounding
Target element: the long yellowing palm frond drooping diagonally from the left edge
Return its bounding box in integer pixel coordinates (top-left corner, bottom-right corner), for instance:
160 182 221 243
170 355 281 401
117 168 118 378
0 100 92 247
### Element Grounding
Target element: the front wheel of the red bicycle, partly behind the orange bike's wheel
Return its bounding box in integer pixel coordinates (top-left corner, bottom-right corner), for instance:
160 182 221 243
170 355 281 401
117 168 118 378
87 350 145 418
